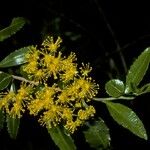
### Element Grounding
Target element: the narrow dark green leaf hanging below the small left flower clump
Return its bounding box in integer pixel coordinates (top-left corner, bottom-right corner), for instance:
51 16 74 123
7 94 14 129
6 115 20 139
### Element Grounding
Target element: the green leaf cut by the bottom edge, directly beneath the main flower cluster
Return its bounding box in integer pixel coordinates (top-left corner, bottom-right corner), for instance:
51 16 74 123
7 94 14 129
47 126 76 150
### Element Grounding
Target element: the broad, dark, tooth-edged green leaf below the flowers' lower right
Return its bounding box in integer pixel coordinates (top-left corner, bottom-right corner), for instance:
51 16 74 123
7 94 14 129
83 118 110 149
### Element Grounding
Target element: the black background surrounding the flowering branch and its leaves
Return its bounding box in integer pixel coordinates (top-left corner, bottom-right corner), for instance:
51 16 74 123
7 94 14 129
0 0 150 150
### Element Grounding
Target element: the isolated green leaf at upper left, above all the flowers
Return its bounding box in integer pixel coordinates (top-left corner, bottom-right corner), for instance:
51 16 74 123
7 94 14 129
0 17 26 42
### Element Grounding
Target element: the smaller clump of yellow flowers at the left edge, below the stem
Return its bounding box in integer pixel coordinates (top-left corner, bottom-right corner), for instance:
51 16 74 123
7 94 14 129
0 83 33 118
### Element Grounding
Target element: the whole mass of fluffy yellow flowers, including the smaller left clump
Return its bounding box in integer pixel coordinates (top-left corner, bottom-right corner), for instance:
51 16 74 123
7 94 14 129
0 37 99 133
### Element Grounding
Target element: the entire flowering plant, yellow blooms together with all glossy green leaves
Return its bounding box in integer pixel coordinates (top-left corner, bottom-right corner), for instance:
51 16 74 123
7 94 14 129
0 18 150 150
